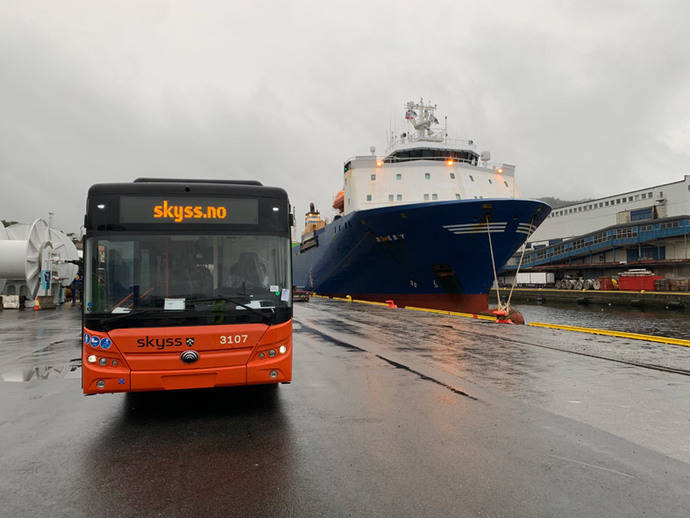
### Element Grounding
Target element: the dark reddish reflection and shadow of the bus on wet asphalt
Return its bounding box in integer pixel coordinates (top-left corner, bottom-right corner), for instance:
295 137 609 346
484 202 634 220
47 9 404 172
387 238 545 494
80 386 298 516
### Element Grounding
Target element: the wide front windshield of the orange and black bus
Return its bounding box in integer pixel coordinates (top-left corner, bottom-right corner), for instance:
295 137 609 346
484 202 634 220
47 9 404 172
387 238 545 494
84 236 292 327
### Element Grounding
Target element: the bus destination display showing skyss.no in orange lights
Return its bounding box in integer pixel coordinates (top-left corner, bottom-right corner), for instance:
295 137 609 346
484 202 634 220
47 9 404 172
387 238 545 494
120 196 259 225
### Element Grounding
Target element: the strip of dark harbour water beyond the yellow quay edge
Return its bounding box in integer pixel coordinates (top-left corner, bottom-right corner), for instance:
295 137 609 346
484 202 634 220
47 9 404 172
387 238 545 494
515 303 690 339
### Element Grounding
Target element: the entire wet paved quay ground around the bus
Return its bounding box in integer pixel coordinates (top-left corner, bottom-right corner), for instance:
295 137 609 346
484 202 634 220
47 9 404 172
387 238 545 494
0 300 690 517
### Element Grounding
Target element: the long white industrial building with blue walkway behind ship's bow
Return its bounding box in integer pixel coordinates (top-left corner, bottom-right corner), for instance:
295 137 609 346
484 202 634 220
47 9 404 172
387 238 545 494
503 175 690 279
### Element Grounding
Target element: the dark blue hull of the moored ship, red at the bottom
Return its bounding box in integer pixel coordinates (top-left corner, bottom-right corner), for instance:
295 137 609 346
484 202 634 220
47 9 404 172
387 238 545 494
292 199 551 313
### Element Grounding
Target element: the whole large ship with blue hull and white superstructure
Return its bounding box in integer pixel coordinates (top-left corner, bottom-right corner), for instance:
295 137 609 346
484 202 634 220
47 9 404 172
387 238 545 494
293 100 551 313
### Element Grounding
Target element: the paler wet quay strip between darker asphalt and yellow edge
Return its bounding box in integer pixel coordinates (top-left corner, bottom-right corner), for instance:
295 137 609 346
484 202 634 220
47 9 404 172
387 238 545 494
296 300 690 466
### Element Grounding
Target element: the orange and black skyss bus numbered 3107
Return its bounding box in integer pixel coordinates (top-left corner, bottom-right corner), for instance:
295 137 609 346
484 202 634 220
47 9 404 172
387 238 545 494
82 178 292 394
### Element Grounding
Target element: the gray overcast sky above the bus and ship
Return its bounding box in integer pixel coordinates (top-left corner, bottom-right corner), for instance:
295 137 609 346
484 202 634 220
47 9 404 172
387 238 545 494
0 0 690 236
